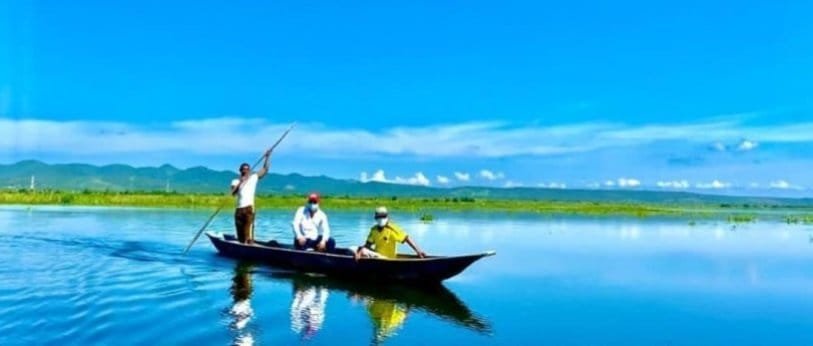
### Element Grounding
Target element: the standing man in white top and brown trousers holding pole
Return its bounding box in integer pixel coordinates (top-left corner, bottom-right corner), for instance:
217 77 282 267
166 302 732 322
231 150 271 244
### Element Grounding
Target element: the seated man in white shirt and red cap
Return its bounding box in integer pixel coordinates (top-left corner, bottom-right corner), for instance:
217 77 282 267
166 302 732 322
291 193 336 252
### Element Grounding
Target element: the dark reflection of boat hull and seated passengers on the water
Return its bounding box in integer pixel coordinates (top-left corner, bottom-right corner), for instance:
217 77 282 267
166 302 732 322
270 272 492 343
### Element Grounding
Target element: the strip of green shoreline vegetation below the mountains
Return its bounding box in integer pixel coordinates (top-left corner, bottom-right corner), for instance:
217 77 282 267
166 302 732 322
0 190 813 226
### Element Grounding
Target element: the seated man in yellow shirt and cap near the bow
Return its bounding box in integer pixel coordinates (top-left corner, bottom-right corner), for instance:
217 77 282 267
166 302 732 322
354 207 426 260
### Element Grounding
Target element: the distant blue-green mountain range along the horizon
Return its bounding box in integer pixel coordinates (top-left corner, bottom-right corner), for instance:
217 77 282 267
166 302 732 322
0 160 813 206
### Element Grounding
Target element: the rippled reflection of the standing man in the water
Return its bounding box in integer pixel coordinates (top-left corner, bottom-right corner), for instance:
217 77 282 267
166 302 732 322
228 262 254 346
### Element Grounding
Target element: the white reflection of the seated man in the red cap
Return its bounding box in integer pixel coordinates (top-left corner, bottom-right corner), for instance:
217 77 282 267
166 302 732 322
291 281 328 340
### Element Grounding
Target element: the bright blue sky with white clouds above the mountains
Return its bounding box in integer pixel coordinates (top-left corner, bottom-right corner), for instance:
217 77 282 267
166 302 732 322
0 1 813 195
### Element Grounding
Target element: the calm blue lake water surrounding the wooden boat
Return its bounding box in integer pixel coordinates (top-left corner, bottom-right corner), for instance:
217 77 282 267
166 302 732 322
0 207 813 345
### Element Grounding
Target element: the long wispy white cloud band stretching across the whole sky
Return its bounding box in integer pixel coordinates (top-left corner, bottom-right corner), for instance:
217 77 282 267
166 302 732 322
0 117 813 158
